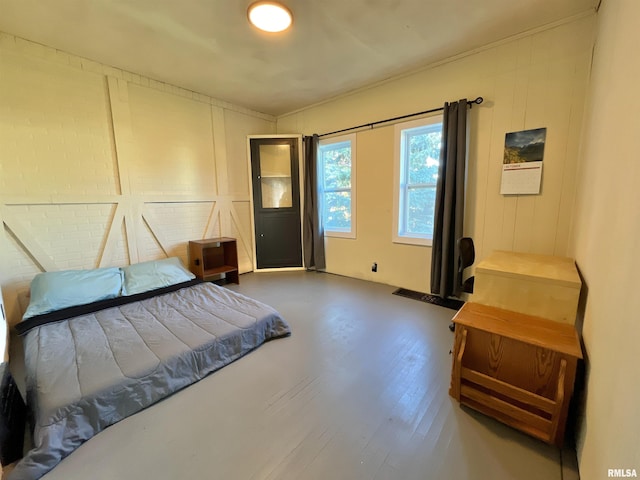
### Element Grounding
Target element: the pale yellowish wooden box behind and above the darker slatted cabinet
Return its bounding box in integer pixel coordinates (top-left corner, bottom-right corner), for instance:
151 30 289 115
472 251 582 325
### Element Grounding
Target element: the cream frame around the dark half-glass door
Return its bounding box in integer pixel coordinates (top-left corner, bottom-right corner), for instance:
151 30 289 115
247 133 306 272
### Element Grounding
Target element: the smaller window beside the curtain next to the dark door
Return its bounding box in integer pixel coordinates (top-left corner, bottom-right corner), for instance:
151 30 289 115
318 135 356 238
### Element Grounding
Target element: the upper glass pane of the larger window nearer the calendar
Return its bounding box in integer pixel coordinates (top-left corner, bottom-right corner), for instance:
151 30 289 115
405 131 442 184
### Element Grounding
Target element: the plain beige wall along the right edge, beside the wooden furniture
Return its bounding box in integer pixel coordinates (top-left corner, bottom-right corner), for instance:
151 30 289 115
572 0 640 480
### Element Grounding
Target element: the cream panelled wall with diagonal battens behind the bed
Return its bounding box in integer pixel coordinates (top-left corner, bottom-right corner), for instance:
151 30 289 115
0 33 275 330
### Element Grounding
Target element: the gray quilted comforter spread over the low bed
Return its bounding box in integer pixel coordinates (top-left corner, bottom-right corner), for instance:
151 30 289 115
9 283 290 480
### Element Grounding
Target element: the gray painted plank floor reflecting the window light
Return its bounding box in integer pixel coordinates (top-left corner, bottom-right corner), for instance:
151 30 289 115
11 272 577 480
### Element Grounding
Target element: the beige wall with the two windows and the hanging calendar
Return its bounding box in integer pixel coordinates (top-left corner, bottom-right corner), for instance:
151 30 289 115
278 15 595 291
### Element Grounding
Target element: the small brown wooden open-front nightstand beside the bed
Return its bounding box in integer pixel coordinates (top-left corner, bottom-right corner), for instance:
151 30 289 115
189 237 240 283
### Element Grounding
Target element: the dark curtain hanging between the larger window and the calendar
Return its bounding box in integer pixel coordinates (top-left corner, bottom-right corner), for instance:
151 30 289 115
431 99 467 298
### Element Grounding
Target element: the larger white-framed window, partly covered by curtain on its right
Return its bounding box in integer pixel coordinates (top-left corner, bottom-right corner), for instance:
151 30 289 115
393 115 442 245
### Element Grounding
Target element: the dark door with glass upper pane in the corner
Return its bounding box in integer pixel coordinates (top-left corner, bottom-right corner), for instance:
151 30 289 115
250 138 302 269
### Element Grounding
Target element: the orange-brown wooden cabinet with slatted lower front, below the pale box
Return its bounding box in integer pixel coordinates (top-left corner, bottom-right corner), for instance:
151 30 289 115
449 303 582 446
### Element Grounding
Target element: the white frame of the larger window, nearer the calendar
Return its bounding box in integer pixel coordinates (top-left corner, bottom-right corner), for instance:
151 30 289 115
392 115 443 246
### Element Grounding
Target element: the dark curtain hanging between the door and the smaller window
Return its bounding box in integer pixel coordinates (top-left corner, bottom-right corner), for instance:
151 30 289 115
302 135 326 270
